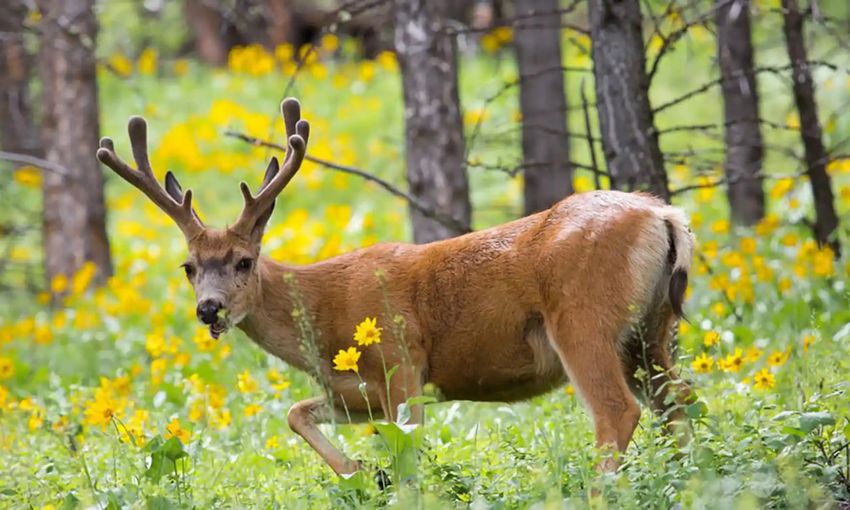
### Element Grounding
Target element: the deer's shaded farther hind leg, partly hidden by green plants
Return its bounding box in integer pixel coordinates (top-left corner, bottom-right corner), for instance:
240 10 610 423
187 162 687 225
626 303 694 445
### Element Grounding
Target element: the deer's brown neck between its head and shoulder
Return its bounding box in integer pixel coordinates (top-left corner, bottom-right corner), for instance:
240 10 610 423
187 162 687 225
238 257 315 371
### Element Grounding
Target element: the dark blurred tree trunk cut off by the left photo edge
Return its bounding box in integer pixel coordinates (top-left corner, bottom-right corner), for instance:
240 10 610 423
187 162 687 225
0 0 41 160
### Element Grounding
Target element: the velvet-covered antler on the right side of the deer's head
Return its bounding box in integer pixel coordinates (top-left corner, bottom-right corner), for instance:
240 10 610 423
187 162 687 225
233 98 310 234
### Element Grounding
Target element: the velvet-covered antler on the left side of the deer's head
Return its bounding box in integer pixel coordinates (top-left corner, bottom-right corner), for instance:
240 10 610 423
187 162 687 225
97 116 204 238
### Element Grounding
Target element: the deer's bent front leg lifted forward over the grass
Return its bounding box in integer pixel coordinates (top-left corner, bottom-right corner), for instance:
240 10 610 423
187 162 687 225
287 397 361 475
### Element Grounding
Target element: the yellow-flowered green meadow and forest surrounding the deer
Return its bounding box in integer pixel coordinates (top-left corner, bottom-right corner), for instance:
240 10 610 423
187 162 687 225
0 0 850 508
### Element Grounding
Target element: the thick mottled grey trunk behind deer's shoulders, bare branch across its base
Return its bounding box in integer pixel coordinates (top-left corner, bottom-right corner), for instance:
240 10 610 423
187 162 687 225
395 0 471 243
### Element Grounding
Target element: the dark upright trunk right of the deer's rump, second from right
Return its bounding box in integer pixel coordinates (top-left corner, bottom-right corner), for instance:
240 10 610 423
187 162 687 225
716 0 764 225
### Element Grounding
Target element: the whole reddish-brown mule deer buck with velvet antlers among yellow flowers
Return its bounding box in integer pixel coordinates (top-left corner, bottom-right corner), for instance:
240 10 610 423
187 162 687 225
97 99 693 474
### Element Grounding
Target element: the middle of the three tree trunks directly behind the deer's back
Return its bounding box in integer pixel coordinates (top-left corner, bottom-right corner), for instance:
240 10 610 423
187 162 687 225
514 0 573 215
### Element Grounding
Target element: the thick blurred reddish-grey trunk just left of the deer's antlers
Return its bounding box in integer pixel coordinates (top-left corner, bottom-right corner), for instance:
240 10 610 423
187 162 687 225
38 0 112 294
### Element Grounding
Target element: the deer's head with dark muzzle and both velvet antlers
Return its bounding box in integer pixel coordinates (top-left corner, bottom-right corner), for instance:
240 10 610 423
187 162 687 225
97 98 310 338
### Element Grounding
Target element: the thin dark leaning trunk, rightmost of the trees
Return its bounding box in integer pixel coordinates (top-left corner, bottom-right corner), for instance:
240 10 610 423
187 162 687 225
782 0 839 255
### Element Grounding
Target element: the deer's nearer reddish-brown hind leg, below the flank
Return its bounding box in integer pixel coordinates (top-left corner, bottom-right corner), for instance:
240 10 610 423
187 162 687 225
547 314 640 471
